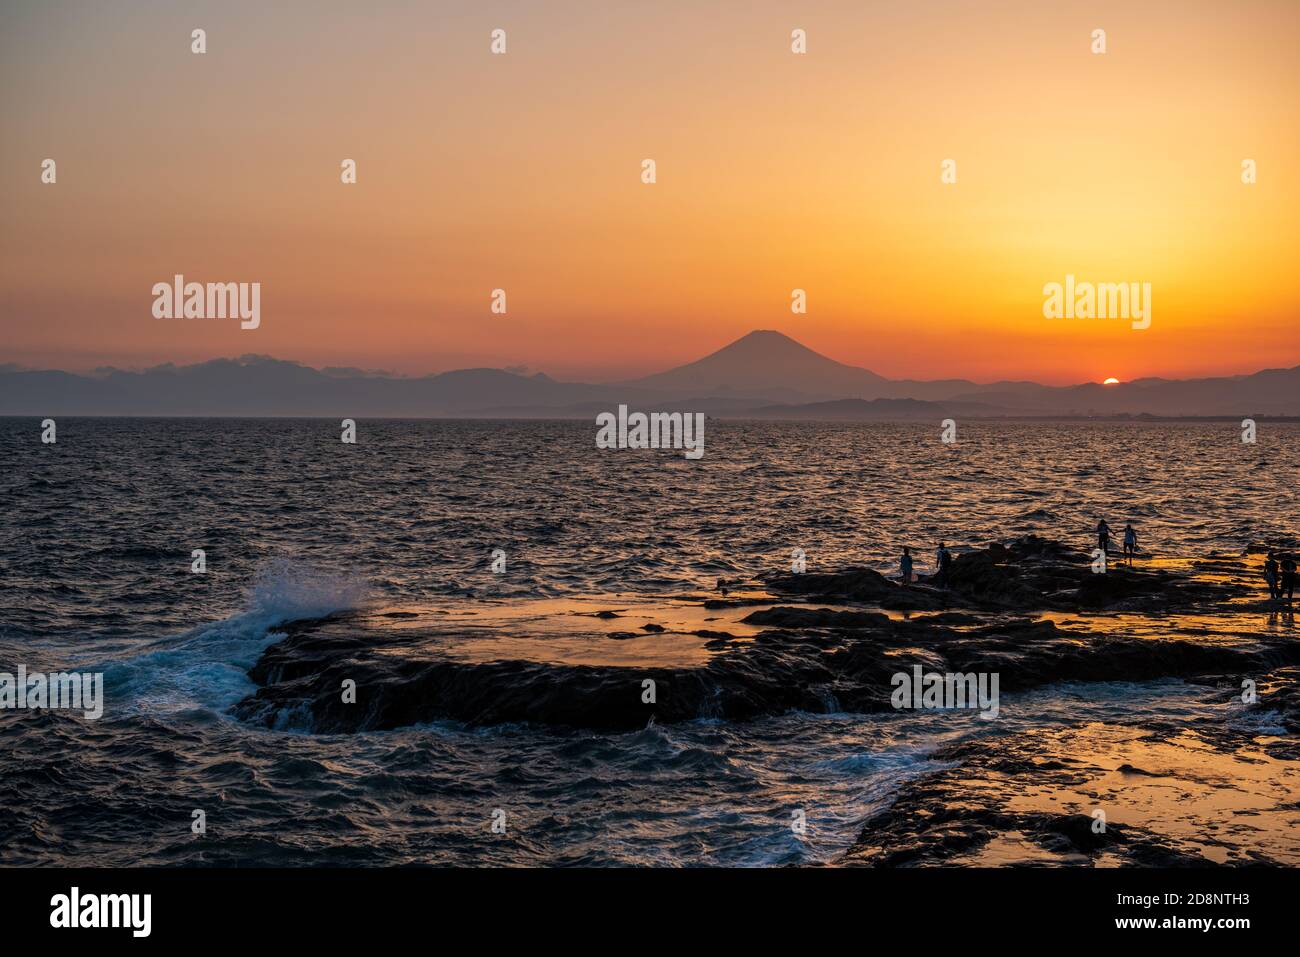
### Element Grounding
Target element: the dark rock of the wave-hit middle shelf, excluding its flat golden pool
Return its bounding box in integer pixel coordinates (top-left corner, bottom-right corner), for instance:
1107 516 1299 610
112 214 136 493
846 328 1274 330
228 536 1300 733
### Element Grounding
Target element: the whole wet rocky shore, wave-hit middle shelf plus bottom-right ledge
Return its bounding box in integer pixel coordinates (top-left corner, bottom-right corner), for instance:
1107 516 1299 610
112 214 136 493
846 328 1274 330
220 536 1300 866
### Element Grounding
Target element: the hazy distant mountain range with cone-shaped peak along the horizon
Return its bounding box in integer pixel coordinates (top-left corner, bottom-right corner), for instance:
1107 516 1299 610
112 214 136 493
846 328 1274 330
0 330 1300 420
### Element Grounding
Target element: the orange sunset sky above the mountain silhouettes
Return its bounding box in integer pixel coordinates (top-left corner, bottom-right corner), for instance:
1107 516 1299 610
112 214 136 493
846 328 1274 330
0 0 1300 384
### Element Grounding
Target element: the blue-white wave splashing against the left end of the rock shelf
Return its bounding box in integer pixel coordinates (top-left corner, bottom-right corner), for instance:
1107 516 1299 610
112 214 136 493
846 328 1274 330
94 557 369 716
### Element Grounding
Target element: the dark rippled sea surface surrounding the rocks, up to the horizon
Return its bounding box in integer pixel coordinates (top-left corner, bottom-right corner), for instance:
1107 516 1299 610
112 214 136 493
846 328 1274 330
0 417 1300 866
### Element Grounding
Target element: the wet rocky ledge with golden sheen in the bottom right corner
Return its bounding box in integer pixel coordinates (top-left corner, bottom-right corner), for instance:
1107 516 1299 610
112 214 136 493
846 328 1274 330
841 667 1300 867
